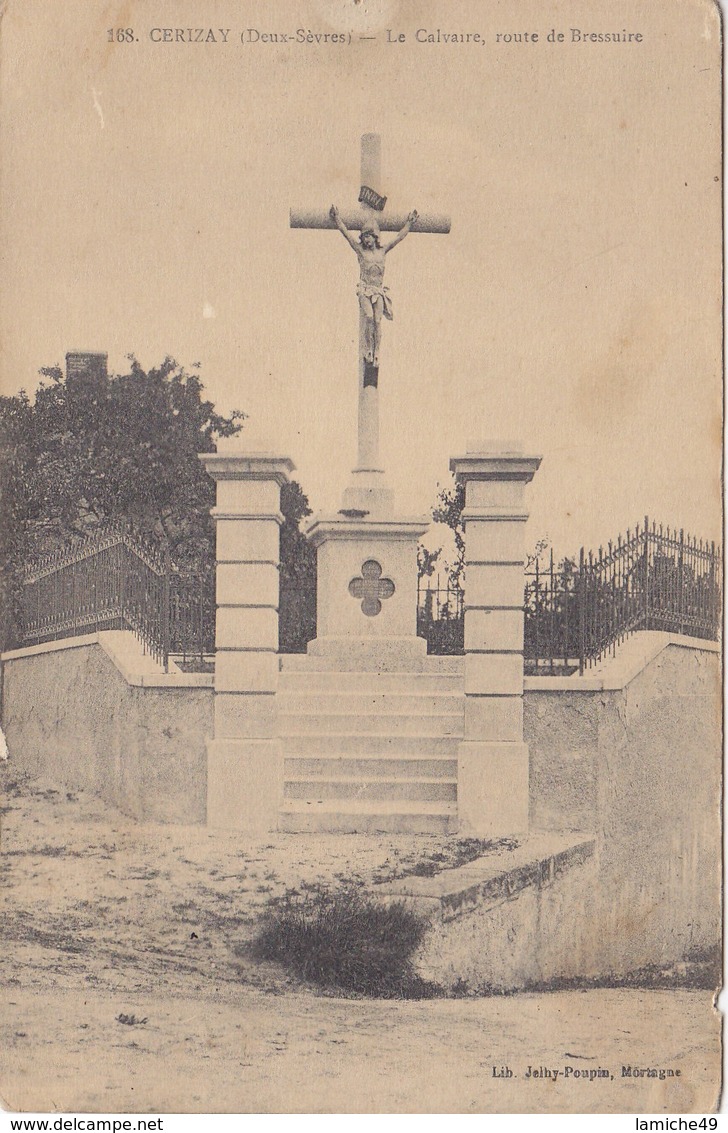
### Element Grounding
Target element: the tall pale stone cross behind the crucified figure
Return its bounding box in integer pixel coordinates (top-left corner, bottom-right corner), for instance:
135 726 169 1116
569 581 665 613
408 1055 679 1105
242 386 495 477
291 134 449 472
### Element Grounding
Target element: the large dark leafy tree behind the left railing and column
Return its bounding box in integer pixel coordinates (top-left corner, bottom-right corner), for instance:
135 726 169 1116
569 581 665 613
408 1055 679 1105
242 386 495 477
0 356 317 642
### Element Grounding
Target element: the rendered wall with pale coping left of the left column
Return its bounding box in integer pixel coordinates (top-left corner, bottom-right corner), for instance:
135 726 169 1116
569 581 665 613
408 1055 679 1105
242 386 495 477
2 633 213 824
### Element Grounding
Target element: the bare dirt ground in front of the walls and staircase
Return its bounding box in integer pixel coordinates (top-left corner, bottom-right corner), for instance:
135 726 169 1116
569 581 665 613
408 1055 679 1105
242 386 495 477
0 761 720 1114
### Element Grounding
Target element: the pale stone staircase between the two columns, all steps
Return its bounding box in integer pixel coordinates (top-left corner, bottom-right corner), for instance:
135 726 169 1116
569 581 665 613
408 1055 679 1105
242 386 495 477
279 655 464 834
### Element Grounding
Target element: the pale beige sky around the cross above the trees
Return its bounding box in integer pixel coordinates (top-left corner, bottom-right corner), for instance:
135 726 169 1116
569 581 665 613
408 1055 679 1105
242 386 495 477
0 0 721 552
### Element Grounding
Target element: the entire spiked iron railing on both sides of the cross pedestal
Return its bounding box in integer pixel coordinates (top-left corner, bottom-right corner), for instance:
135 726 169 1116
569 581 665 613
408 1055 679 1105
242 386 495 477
23 520 722 673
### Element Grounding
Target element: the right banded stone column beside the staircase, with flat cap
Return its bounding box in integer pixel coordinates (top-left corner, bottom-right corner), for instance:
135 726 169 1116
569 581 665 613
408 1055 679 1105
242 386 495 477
449 443 541 837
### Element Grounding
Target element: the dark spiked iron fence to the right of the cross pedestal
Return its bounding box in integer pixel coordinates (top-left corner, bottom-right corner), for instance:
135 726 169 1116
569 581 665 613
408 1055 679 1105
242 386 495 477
418 519 722 674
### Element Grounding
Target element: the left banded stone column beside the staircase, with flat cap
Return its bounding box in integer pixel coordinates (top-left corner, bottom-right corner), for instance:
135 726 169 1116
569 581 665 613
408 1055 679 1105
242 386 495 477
199 437 294 832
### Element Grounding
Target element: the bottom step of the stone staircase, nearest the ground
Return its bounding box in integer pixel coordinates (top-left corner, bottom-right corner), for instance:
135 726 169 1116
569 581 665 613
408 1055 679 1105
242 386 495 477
279 799 457 834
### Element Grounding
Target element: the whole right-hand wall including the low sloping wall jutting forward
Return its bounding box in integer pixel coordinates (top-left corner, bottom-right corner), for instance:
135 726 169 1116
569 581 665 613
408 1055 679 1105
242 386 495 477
377 633 721 991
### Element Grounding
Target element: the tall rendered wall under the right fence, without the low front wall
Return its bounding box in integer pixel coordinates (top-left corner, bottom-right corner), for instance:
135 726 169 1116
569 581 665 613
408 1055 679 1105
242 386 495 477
524 634 721 971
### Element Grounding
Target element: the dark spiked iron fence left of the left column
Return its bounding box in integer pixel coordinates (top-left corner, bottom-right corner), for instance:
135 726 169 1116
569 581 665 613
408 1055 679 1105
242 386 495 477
23 528 215 670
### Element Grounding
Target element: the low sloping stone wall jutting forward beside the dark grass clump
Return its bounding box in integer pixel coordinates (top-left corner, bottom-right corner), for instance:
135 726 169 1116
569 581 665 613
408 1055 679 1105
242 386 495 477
405 835 719 991
